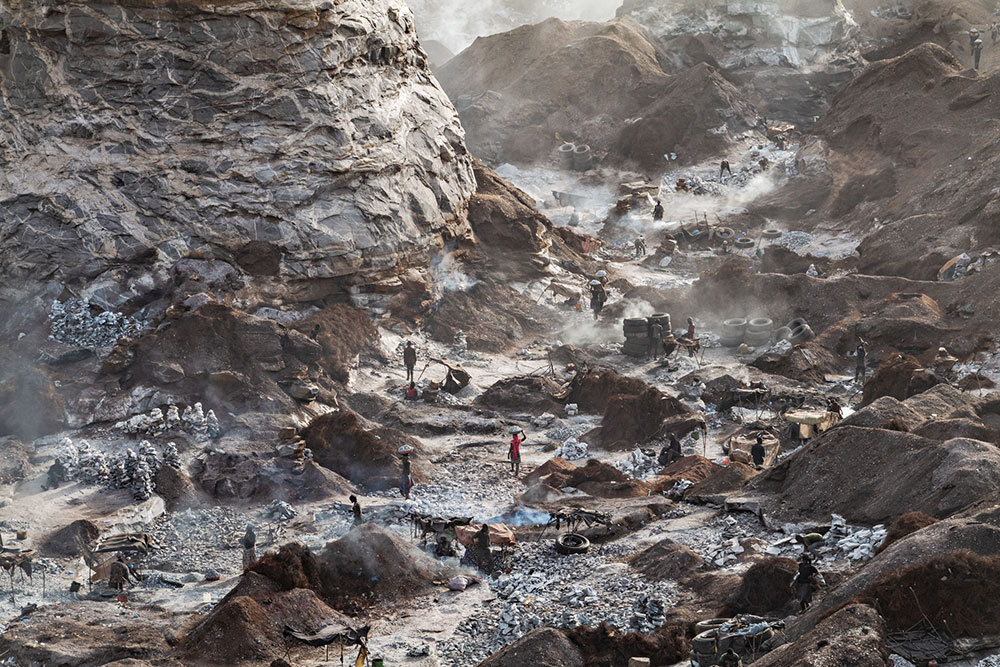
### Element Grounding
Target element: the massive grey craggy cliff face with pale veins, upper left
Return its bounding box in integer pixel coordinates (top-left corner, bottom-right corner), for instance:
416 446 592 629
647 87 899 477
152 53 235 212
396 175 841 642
0 0 475 316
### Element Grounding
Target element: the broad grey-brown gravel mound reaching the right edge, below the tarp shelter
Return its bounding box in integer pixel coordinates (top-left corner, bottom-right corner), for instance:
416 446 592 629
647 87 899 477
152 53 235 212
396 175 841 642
751 426 1000 524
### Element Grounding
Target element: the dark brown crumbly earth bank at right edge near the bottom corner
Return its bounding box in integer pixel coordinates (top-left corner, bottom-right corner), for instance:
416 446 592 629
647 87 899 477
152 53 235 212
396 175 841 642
861 551 1000 637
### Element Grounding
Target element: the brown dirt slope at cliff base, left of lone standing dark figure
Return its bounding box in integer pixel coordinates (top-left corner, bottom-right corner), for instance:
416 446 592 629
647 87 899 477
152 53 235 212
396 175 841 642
291 303 379 383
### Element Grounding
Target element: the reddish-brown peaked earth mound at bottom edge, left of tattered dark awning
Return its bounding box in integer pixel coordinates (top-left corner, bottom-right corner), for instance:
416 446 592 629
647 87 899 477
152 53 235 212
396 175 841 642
181 572 349 665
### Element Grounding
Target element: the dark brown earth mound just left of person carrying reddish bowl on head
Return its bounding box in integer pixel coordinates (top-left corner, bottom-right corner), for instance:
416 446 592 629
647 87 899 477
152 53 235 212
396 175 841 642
302 410 427 491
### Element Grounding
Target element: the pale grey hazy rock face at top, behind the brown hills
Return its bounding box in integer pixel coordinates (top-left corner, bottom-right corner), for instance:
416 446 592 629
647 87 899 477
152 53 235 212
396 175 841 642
618 0 861 121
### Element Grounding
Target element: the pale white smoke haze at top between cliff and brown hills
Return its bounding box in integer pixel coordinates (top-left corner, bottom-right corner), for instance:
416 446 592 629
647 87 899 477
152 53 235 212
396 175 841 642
409 0 621 53
